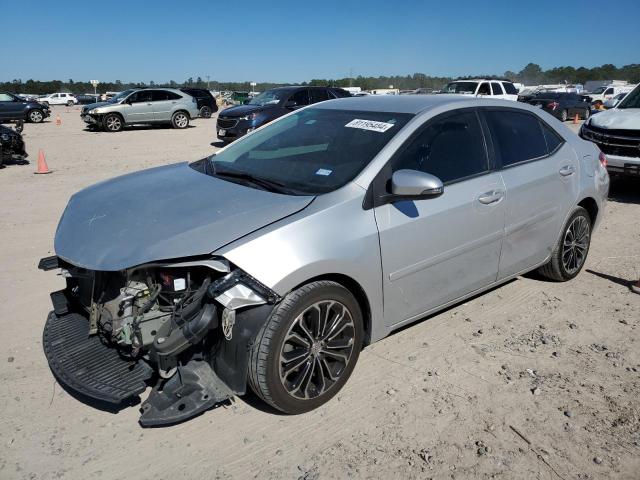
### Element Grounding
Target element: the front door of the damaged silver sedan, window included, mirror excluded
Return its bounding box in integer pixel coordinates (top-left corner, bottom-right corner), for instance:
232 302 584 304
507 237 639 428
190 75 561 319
375 109 505 326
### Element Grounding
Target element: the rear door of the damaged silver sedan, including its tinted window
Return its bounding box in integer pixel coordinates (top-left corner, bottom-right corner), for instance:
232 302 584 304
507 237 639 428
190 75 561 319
482 107 579 278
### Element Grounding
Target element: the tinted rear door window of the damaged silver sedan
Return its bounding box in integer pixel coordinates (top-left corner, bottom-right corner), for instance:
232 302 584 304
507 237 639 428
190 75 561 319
485 110 547 167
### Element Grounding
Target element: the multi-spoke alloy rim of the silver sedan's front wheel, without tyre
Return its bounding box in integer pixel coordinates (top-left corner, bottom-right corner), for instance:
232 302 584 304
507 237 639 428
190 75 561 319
279 300 355 400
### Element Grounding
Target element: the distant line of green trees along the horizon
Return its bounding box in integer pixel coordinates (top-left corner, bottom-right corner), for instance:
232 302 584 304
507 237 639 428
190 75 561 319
0 63 640 95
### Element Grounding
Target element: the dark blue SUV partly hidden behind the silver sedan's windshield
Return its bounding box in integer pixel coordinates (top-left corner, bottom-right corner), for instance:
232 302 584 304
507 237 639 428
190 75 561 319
217 87 351 142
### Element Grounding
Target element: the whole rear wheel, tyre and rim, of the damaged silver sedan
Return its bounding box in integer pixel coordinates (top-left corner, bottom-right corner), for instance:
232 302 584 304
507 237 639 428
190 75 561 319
538 207 591 282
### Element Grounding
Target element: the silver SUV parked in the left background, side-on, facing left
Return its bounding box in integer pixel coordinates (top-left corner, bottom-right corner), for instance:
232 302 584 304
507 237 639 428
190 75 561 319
80 88 199 132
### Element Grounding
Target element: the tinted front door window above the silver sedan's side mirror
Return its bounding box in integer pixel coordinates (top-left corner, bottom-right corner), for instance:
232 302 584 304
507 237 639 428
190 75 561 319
394 110 489 183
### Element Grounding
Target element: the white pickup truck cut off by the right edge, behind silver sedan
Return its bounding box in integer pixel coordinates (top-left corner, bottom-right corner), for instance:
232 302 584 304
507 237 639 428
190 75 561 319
580 85 640 177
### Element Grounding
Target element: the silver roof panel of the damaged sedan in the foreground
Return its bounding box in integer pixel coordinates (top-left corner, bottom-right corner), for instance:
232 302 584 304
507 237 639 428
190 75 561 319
314 94 510 114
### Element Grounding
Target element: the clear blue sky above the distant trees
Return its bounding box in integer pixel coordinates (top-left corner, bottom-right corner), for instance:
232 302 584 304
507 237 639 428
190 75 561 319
0 0 640 82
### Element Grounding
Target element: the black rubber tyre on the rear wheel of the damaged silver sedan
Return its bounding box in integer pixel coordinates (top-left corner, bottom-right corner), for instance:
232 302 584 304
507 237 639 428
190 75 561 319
538 207 592 282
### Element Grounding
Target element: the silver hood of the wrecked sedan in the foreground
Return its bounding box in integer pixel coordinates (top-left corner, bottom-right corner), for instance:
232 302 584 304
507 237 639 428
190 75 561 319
55 163 314 271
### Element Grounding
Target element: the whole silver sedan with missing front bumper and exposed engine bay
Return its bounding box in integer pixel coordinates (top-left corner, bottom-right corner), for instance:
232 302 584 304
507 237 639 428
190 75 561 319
39 95 609 426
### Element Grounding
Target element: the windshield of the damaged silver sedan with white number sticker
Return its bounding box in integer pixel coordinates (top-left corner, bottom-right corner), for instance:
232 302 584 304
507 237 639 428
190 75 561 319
206 108 413 195
